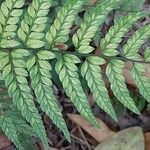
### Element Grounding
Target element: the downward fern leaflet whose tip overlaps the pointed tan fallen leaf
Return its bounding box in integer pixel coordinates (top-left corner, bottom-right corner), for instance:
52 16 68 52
55 54 99 126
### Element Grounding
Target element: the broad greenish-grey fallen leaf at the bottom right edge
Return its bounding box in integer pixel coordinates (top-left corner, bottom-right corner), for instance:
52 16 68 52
95 127 144 150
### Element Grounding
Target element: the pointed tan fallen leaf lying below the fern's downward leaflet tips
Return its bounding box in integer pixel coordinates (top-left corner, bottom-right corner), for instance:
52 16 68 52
67 114 115 142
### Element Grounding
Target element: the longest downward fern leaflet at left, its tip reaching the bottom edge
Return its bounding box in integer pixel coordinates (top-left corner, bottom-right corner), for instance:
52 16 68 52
3 49 48 149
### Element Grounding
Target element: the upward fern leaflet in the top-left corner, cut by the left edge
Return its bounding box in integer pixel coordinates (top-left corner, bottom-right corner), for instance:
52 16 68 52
0 0 25 48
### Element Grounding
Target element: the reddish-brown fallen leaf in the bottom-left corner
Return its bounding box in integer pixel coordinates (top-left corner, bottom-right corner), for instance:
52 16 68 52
0 134 11 150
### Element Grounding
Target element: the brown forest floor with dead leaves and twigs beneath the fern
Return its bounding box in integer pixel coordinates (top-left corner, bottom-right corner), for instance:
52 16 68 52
0 1 150 150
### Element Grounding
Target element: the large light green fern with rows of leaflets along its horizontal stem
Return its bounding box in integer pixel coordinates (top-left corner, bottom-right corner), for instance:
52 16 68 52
0 0 150 150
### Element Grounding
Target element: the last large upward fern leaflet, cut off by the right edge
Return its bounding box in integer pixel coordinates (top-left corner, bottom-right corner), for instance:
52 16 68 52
123 24 150 60
